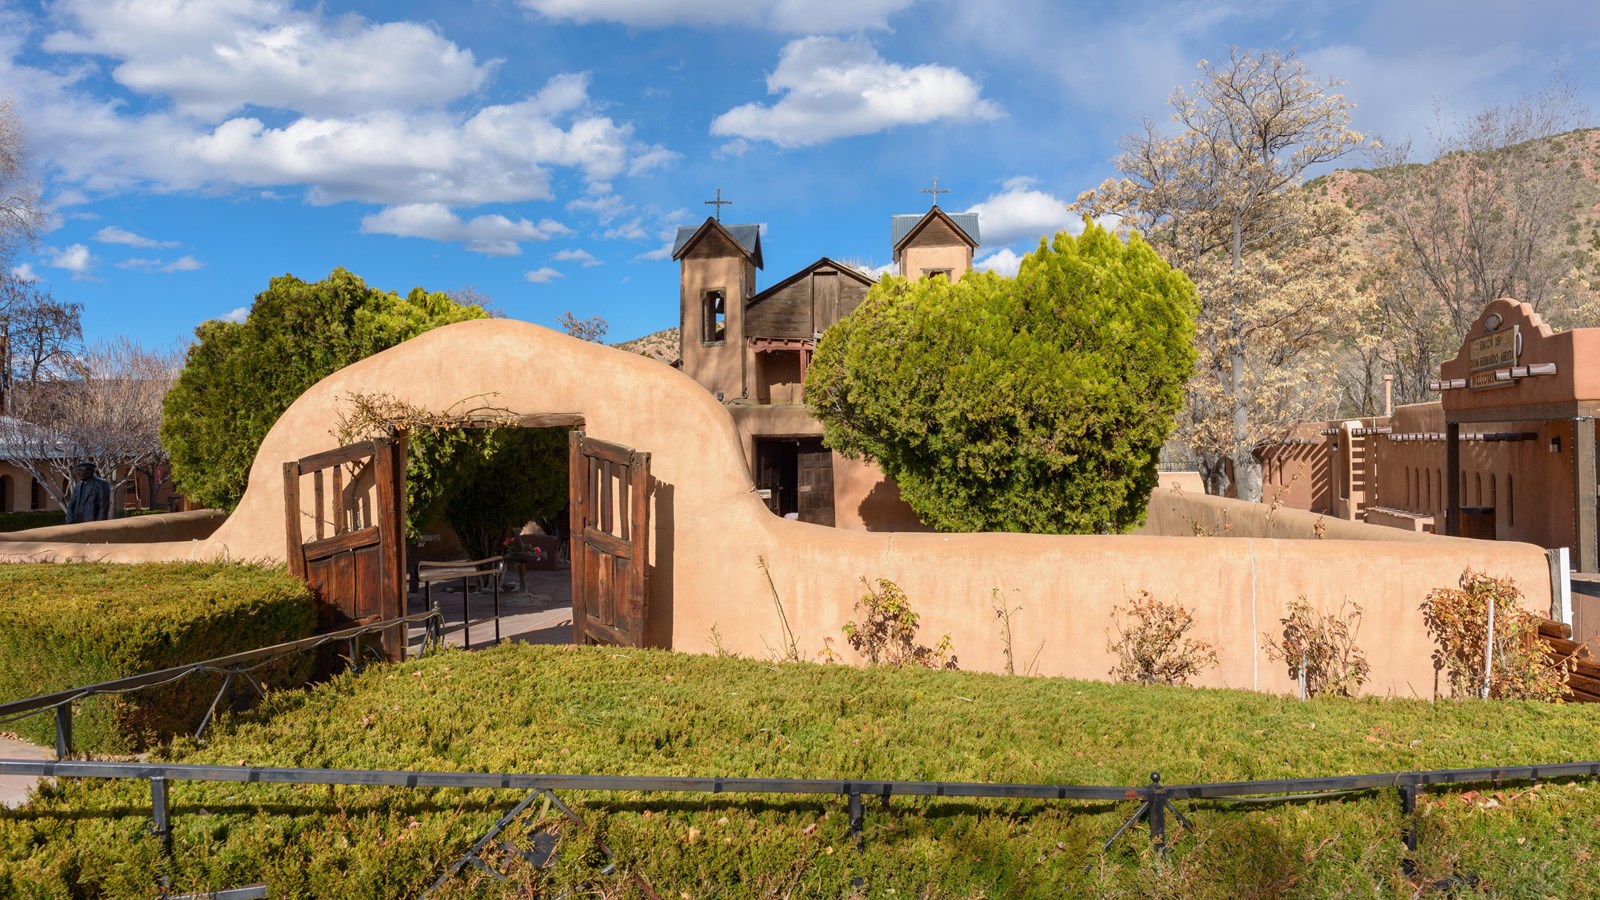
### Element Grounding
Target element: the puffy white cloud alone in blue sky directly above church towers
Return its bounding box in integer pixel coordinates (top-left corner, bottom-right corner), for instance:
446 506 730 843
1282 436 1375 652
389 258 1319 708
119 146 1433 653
710 37 1000 147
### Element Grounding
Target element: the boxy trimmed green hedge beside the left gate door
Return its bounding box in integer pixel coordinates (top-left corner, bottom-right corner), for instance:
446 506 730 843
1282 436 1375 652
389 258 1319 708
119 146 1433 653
0 562 317 753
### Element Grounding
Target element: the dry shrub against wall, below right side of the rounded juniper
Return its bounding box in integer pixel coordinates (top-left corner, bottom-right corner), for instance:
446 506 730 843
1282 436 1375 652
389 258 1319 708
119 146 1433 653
1106 591 1216 684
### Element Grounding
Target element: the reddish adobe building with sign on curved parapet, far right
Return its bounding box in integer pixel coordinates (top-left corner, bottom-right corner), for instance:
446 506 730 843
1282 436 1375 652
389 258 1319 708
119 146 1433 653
1259 298 1600 573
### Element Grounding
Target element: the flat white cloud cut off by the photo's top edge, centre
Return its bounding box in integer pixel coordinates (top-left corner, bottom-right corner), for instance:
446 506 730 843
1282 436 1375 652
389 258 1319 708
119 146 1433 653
522 0 917 34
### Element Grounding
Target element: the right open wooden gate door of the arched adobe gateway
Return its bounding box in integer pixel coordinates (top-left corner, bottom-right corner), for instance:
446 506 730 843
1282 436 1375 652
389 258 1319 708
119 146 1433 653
570 431 651 647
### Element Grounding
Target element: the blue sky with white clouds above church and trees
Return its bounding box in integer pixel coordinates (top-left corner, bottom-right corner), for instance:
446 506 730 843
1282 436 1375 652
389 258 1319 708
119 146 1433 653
0 0 1600 344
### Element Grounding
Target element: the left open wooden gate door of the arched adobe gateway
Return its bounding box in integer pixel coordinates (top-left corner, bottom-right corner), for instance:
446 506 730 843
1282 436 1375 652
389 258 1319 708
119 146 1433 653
283 437 405 660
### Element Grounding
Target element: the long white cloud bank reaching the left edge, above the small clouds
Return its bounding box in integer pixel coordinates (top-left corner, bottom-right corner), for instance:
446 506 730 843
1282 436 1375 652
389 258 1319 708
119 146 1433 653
0 28 667 207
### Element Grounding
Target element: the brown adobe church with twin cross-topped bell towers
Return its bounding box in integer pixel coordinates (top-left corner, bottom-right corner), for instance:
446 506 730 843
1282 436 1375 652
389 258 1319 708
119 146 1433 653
672 188 979 532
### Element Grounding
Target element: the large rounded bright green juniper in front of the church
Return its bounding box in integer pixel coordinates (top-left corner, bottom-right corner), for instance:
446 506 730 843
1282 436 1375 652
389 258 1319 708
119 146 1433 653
805 223 1195 533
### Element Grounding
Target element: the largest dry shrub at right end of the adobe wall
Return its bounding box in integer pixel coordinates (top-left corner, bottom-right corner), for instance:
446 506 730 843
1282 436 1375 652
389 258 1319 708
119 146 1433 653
1422 569 1571 701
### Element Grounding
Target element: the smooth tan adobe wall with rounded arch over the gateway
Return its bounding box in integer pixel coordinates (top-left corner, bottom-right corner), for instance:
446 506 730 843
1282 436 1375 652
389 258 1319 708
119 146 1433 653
5 319 1549 697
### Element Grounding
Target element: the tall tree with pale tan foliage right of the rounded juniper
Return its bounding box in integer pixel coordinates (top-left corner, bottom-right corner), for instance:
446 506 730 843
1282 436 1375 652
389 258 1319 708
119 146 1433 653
1075 50 1365 500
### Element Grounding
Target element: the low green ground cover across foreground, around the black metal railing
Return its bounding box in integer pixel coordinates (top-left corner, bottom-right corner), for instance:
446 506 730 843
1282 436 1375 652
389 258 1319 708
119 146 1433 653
0 645 1600 898
